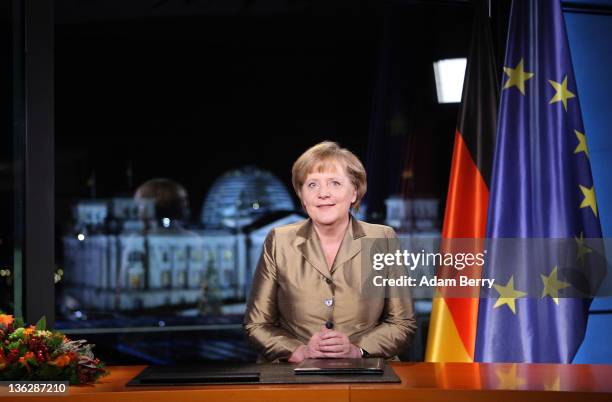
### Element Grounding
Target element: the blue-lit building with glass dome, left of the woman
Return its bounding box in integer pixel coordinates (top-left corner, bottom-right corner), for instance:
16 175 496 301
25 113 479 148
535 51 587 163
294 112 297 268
58 166 303 358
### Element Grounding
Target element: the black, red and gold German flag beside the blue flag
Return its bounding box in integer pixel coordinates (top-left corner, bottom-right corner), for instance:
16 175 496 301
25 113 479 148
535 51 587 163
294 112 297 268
425 0 499 362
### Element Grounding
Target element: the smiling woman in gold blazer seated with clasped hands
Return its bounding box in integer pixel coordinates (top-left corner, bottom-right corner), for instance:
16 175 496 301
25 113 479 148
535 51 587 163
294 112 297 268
244 141 415 363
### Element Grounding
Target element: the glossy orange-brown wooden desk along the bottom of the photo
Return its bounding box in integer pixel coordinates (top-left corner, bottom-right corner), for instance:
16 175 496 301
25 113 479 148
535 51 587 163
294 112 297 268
14 363 612 402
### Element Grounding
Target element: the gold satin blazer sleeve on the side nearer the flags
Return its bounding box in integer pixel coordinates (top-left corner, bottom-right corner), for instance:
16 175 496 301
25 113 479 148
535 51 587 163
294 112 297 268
354 228 416 358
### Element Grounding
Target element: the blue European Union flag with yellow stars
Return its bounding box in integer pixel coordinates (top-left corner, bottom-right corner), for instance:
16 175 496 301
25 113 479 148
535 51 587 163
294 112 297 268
475 0 601 363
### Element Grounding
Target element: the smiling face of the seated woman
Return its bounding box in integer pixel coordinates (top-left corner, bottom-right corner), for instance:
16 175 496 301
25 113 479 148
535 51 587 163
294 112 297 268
300 162 357 229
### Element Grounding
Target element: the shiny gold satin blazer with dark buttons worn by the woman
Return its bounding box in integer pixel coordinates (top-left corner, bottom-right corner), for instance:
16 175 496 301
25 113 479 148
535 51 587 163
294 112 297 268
244 217 416 361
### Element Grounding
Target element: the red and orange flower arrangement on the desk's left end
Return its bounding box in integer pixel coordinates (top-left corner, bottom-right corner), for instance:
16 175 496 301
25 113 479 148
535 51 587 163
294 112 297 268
0 312 108 385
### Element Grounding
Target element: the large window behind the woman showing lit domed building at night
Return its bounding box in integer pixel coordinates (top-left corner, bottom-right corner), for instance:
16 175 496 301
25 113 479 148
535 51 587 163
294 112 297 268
51 0 471 363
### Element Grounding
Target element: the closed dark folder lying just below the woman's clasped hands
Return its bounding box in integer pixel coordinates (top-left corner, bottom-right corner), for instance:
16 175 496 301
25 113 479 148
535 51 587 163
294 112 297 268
293 358 385 374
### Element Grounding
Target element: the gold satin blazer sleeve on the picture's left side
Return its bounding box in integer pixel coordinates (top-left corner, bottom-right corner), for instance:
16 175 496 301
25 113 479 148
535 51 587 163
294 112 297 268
243 230 303 361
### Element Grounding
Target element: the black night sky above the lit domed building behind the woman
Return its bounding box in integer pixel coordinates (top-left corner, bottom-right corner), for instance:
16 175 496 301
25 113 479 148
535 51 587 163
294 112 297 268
55 2 471 229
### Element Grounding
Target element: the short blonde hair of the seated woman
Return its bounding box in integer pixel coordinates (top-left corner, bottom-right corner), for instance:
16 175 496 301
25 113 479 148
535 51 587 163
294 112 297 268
291 141 368 211
